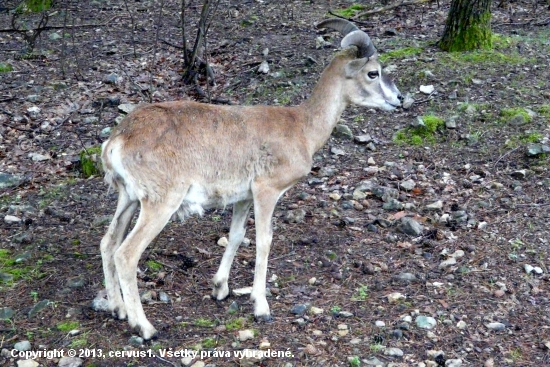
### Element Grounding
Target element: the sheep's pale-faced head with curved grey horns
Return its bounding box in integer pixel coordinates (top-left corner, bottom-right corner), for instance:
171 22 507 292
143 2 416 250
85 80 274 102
317 19 401 111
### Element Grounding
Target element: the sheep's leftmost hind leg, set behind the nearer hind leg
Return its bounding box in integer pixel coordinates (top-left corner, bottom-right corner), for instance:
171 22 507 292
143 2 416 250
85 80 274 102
100 188 138 320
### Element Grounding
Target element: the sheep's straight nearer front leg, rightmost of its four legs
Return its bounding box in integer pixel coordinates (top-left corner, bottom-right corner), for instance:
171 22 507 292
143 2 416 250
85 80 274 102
250 185 284 321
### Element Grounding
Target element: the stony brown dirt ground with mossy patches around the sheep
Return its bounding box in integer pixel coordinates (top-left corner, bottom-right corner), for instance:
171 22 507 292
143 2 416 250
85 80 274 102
0 0 550 367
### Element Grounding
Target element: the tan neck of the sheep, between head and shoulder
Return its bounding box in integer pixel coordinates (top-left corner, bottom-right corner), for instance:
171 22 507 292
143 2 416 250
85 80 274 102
300 60 348 156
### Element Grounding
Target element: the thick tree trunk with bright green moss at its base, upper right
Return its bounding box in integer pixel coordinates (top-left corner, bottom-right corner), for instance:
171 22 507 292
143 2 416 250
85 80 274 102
439 0 492 51
